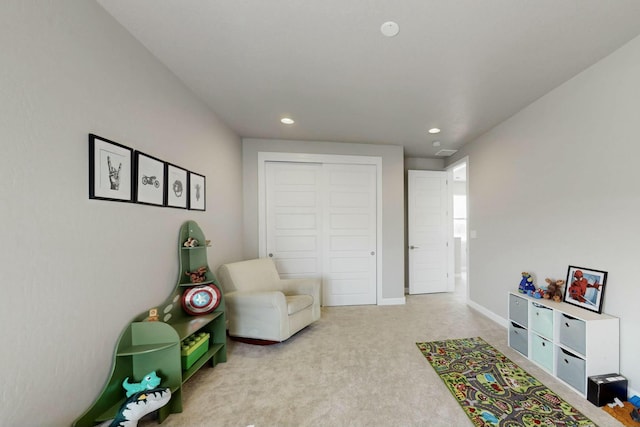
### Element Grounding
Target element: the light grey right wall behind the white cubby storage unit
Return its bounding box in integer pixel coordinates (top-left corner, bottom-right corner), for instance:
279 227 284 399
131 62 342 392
451 33 640 390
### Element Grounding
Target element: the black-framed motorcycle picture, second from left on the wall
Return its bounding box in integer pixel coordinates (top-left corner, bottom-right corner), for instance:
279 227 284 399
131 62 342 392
135 151 166 206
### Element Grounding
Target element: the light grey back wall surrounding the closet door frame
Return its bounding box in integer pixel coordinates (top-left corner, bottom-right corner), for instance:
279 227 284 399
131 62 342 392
242 138 405 300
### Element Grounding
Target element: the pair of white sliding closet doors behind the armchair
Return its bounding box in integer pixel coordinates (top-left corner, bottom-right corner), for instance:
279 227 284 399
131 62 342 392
265 162 377 306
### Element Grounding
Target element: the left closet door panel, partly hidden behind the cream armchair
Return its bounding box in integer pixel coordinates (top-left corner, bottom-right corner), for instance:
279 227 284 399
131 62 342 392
265 162 323 278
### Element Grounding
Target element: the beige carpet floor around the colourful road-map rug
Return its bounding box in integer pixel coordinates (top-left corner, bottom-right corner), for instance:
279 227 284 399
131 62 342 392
139 294 622 427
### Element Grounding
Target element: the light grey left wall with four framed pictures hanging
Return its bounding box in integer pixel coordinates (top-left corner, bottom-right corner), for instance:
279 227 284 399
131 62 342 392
0 0 242 426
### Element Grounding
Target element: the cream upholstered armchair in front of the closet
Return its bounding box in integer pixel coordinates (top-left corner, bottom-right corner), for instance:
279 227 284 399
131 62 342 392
218 258 320 343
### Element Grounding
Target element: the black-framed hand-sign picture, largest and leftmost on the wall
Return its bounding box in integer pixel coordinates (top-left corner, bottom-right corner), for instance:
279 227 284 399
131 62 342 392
89 133 133 202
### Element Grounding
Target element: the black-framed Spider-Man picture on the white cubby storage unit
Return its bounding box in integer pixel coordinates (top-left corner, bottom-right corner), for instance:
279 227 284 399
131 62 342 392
563 265 607 313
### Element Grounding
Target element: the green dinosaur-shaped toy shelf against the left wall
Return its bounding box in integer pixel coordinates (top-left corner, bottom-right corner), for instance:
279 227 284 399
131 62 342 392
73 221 227 427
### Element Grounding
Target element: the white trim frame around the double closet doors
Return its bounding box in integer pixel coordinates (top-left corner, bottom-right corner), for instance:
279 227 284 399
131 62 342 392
258 151 383 305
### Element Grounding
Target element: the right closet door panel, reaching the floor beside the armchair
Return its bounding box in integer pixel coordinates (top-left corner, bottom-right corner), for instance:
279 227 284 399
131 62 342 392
323 164 377 306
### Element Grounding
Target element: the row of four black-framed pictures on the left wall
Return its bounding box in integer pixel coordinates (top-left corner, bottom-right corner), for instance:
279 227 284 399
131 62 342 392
89 133 206 211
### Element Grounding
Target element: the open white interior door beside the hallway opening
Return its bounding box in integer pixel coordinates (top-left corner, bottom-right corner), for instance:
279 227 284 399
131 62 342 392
408 170 453 294
